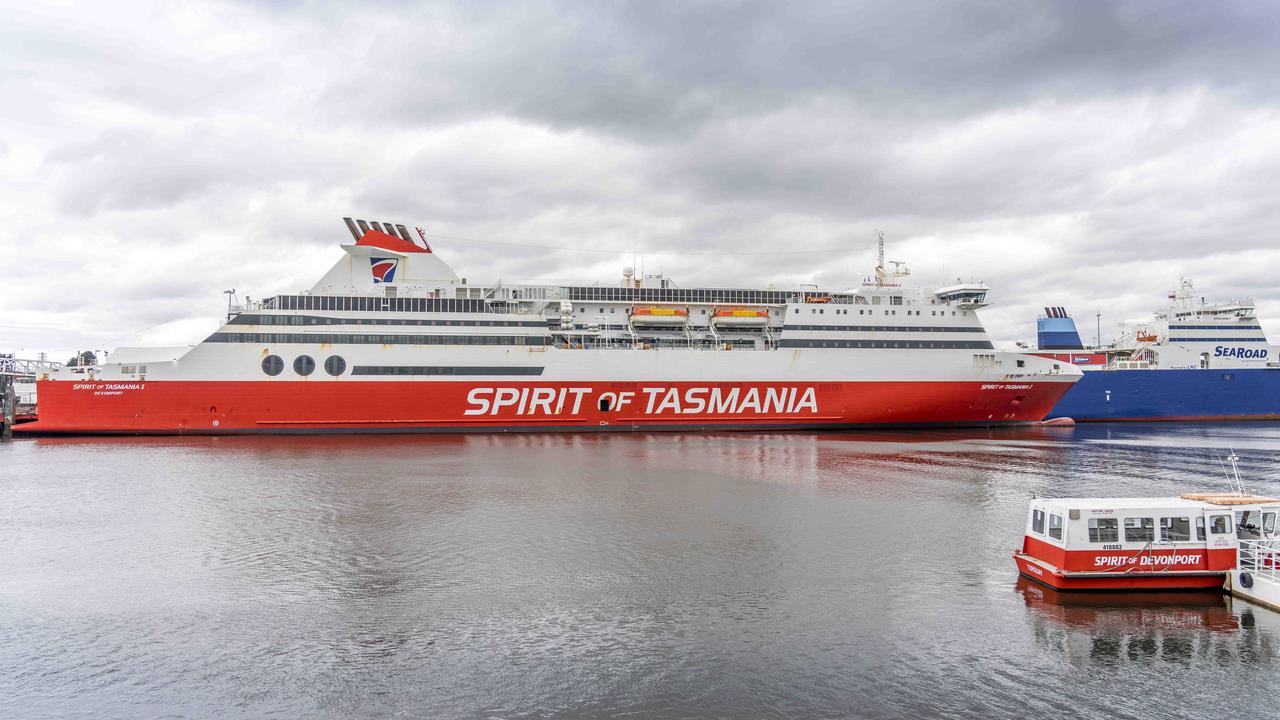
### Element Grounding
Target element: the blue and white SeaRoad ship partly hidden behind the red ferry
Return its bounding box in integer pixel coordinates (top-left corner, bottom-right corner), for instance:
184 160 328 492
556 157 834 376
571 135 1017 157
1036 279 1280 421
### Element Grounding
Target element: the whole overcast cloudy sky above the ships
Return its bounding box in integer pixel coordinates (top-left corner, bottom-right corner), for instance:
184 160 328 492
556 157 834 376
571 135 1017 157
0 0 1280 359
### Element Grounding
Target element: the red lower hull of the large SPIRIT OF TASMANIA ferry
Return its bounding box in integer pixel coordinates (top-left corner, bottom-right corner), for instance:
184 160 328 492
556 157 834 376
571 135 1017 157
24 380 1071 434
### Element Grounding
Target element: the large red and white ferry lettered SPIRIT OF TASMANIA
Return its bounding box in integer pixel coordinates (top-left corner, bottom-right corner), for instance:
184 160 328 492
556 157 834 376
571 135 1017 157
19 218 1080 434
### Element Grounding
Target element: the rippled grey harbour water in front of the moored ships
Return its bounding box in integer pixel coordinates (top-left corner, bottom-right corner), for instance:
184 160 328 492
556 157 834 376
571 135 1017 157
0 423 1280 719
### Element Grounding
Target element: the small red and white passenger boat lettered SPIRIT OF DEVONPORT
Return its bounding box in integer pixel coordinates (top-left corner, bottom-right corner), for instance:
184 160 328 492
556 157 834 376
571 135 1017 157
1014 456 1280 591
